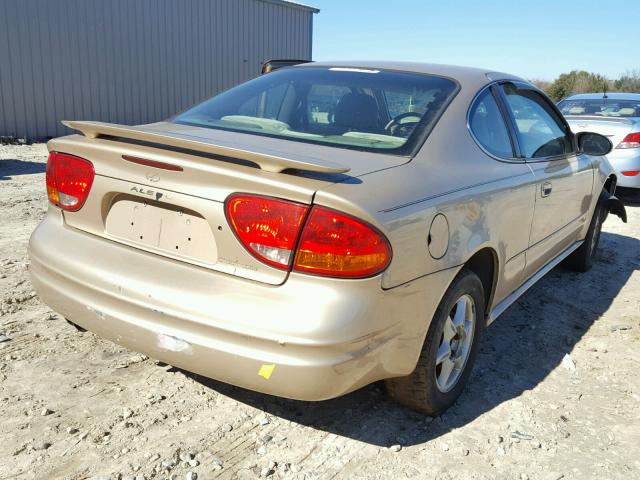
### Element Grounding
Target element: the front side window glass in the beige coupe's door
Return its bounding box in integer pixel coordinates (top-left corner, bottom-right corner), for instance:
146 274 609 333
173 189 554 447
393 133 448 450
503 83 573 158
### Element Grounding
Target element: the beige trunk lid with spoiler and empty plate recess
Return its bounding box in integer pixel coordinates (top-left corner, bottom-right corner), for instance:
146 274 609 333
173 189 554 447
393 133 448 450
49 122 408 285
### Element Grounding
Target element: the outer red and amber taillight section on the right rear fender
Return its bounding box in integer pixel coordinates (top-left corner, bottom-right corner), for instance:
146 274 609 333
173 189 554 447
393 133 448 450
293 206 391 278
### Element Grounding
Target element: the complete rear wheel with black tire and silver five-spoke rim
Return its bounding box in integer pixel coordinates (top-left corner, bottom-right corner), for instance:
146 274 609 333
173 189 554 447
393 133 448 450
386 269 485 415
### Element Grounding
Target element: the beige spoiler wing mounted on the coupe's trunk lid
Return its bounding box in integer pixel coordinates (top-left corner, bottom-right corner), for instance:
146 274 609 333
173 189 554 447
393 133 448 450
62 121 350 173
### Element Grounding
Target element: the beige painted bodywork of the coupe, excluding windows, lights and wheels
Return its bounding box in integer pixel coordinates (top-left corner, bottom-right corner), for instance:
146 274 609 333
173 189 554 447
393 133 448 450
30 63 611 400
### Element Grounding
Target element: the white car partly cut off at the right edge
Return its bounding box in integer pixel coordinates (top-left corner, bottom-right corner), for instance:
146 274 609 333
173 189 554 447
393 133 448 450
558 93 640 188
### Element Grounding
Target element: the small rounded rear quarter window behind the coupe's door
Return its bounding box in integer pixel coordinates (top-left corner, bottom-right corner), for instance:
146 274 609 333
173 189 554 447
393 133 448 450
469 89 514 158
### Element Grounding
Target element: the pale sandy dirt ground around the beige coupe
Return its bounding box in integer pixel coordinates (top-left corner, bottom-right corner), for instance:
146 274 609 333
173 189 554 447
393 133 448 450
0 145 640 480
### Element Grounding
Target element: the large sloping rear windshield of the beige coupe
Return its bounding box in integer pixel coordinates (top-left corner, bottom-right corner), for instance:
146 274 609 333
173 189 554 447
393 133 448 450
173 67 457 155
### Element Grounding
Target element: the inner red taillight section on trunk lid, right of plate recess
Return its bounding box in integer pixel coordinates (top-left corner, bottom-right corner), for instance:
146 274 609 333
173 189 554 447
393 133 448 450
226 195 308 270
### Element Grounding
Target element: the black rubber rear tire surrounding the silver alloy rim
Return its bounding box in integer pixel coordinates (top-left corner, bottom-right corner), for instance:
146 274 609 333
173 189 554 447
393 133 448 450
385 269 486 416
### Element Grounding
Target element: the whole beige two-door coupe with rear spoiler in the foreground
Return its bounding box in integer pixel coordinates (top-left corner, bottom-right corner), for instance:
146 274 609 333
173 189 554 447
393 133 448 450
29 62 625 415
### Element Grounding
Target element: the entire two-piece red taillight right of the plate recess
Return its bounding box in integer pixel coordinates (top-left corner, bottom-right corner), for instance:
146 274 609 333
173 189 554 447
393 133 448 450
225 194 391 278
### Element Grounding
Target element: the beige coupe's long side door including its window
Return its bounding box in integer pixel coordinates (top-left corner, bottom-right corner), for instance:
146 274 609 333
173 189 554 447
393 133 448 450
501 82 593 278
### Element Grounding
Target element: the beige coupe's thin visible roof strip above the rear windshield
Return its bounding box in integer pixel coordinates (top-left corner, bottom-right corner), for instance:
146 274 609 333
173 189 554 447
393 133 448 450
293 60 526 83
